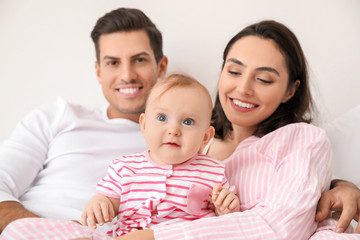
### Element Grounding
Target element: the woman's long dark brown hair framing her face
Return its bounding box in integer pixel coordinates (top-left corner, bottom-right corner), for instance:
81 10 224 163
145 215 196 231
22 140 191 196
211 21 315 140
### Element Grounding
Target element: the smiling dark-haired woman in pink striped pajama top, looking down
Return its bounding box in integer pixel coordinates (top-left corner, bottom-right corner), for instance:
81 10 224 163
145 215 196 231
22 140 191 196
120 21 358 239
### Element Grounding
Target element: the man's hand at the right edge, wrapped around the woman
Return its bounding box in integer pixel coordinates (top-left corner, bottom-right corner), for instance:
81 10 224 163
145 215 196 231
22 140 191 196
315 180 360 233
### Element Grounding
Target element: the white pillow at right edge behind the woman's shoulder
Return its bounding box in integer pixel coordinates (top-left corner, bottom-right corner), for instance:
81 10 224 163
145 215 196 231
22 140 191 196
324 105 360 187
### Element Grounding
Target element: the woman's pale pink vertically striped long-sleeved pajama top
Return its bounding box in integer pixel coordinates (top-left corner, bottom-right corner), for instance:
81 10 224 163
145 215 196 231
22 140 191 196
154 123 332 240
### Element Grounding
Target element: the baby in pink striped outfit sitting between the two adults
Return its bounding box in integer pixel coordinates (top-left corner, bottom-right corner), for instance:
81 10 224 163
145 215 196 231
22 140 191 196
82 74 240 237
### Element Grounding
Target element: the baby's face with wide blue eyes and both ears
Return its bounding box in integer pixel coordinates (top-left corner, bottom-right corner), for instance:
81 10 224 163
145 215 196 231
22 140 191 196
140 87 212 165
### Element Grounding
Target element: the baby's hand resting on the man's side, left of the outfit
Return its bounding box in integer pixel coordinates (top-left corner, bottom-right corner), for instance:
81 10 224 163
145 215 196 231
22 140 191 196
81 194 115 229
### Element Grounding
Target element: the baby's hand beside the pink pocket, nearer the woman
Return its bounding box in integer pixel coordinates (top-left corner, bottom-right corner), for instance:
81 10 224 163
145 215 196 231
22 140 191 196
211 184 240 216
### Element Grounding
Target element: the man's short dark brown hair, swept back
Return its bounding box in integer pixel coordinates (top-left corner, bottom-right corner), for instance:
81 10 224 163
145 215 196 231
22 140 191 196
91 8 163 62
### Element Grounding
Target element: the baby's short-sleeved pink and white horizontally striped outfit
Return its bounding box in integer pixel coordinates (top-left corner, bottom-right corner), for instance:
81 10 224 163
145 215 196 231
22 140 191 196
97 151 228 236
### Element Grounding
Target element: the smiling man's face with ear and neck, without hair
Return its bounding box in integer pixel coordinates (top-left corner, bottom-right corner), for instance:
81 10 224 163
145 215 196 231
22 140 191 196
95 31 167 122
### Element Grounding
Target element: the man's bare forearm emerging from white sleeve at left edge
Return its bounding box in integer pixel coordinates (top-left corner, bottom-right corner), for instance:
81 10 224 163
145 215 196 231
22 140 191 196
0 201 40 233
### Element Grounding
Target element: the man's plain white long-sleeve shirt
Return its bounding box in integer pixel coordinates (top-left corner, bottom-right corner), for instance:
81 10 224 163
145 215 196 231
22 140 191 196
0 98 147 221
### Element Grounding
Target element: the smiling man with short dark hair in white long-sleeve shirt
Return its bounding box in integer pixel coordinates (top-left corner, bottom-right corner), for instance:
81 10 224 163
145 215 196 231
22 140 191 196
0 8 360 235
